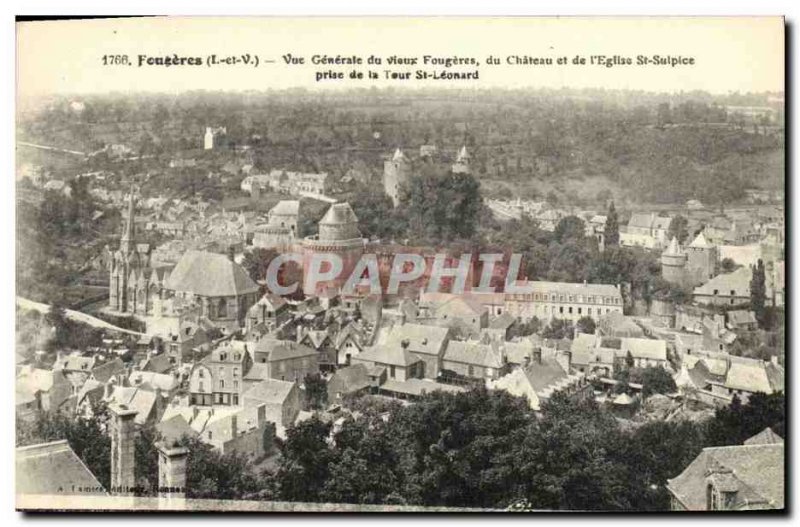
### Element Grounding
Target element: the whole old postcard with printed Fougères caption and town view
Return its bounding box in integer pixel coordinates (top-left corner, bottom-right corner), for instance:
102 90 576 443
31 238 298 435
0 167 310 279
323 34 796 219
15 17 788 512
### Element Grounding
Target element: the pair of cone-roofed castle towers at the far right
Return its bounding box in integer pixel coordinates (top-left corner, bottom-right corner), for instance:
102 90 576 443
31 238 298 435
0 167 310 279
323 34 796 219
661 232 719 286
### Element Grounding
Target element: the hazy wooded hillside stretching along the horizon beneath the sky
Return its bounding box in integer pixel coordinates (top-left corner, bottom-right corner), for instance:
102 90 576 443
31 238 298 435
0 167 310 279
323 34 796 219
18 86 784 205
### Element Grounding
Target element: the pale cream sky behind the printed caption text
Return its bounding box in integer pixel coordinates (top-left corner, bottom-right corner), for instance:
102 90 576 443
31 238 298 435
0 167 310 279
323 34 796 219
17 17 784 98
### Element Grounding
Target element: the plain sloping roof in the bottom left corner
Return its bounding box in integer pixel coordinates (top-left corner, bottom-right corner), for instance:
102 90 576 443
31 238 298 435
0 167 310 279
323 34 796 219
16 439 108 495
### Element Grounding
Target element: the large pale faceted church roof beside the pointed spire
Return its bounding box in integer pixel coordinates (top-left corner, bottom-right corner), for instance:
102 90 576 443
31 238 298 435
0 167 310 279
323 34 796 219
165 251 259 297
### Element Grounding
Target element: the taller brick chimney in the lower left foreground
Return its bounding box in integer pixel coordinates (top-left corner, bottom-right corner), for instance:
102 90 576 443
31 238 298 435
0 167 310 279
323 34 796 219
109 404 138 496
